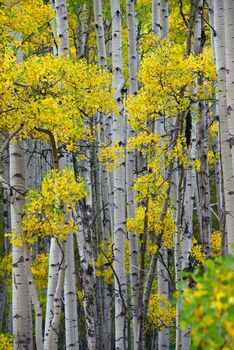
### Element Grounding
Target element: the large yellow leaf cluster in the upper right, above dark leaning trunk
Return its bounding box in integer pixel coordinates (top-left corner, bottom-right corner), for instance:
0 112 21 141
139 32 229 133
127 40 216 130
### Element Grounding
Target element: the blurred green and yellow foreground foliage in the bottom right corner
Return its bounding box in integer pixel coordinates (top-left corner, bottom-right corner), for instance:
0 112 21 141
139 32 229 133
181 255 234 350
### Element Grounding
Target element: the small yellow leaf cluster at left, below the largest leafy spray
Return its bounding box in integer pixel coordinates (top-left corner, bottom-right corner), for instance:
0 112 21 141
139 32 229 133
22 169 87 244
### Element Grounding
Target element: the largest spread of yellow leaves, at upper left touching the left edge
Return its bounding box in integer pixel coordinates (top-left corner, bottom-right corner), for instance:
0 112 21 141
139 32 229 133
0 55 115 150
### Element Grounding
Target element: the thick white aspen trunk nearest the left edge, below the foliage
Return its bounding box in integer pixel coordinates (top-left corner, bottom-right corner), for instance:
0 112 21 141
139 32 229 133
10 142 33 350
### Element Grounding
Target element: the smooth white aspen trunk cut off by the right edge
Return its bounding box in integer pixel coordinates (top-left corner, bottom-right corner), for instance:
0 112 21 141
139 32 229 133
222 0 234 253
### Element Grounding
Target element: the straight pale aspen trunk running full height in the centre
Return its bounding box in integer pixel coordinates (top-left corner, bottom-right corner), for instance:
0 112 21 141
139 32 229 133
111 0 126 350
